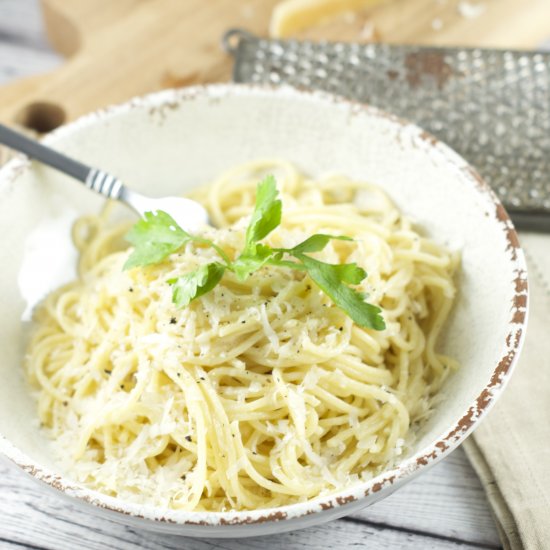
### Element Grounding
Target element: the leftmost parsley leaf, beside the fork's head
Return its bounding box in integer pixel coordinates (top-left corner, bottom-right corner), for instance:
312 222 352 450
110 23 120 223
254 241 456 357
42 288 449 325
123 210 192 270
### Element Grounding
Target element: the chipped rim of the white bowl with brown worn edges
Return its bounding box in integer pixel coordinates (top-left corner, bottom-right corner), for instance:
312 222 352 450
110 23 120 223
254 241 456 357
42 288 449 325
0 83 528 527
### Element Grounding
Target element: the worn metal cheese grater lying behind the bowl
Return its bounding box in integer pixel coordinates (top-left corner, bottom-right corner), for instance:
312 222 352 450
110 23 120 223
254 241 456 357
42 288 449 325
224 29 550 230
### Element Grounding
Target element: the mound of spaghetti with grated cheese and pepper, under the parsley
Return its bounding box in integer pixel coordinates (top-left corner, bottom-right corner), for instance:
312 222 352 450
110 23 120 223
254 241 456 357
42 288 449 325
26 161 459 511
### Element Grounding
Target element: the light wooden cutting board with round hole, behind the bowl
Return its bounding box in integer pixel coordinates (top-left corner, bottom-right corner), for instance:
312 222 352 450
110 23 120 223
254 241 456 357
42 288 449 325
0 0 550 131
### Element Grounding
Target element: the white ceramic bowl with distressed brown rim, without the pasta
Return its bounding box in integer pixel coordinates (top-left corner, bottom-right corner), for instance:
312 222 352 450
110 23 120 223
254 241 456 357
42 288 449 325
0 85 527 537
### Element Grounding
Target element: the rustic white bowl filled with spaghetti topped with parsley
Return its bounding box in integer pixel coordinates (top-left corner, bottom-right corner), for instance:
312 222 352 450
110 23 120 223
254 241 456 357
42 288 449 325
0 85 527 537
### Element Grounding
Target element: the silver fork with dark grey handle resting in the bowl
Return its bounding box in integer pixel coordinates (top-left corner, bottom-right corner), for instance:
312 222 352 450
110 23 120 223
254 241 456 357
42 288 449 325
0 124 209 230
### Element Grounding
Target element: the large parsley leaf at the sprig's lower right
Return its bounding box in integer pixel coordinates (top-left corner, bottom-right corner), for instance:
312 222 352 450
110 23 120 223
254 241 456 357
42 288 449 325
296 253 386 330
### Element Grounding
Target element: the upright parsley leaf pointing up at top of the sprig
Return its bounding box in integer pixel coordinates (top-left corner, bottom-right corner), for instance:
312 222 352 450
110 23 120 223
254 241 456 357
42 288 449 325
244 175 283 254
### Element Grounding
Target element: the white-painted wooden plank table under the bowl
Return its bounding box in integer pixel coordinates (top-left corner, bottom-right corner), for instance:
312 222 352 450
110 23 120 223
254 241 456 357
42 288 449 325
0 0 500 550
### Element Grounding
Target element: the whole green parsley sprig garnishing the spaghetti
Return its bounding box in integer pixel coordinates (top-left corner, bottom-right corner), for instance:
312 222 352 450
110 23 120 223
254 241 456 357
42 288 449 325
124 176 386 330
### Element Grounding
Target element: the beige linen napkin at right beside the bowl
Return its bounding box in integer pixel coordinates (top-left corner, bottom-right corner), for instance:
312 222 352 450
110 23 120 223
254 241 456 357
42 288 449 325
464 233 550 550
